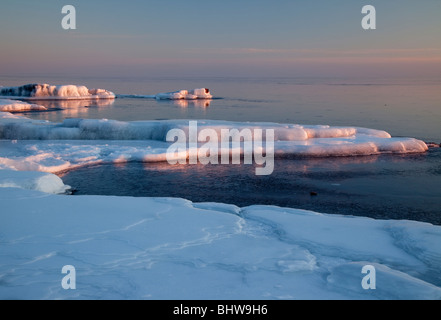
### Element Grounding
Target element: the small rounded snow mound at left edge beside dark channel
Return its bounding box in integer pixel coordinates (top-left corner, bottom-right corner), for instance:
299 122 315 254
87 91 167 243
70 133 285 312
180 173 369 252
0 170 70 194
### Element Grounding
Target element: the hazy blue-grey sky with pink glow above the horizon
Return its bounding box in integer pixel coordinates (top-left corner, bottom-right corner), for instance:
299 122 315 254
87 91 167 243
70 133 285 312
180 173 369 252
0 0 441 77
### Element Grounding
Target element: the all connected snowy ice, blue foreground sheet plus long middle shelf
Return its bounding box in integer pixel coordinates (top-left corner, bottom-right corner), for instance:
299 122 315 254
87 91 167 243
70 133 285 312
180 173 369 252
0 112 441 300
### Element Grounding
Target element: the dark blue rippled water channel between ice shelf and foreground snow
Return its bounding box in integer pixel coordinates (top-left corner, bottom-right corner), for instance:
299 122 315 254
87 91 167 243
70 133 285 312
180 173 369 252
62 148 441 225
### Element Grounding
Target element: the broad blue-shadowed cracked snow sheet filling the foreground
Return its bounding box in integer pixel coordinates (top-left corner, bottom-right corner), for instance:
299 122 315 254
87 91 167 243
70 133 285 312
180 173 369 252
0 188 441 300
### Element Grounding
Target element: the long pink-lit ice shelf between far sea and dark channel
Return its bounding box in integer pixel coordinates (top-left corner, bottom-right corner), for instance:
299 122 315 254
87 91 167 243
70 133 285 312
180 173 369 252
0 113 427 172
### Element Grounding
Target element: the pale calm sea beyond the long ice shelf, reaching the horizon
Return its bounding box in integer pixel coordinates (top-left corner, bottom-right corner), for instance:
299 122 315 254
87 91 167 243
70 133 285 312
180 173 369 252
0 77 441 143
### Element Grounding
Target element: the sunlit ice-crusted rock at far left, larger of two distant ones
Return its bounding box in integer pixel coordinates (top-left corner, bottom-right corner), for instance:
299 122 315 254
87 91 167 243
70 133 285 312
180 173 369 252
0 84 115 100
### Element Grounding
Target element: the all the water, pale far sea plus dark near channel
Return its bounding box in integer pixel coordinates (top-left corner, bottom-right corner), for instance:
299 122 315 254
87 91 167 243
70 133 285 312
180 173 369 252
0 76 441 224
